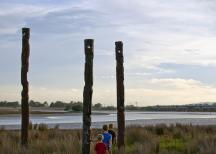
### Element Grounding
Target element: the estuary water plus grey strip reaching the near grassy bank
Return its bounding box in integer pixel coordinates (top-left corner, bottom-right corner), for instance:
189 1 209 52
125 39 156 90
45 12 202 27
0 112 216 129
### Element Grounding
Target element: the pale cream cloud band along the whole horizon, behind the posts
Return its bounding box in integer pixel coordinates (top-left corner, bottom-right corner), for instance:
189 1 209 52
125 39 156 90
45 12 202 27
0 78 216 106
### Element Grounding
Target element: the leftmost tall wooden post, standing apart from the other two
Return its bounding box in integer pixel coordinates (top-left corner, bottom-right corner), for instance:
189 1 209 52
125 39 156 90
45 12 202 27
21 28 30 146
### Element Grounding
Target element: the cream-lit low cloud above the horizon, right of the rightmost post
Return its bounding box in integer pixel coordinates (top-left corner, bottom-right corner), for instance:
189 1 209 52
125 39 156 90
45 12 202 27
126 78 216 106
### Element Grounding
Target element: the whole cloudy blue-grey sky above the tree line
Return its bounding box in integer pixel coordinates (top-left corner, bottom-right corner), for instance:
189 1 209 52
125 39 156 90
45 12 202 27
0 0 216 106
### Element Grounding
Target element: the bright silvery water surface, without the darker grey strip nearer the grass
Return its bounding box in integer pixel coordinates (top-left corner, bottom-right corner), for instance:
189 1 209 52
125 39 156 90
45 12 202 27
0 112 216 126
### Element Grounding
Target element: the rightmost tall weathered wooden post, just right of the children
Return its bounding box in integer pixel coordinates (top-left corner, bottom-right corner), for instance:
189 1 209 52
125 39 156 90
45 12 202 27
115 41 125 153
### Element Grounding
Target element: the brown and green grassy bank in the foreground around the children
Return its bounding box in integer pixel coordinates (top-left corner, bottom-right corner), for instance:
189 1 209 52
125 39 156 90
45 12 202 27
0 124 216 154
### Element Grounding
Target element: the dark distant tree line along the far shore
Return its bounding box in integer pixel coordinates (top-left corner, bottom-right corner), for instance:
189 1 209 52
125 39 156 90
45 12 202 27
0 100 216 112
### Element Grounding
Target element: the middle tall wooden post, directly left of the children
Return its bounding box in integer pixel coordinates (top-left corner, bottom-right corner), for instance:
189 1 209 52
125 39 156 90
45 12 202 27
82 39 94 154
